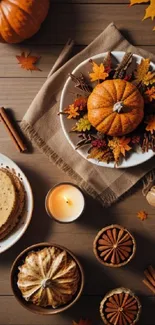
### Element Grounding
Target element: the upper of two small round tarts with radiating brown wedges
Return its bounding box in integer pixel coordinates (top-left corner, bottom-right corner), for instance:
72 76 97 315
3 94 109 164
94 225 136 267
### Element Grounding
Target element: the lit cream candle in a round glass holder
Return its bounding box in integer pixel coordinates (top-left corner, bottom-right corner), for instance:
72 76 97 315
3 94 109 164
45 183 85 223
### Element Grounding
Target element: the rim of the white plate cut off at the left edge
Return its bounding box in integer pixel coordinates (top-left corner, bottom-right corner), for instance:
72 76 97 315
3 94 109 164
0 153 34 254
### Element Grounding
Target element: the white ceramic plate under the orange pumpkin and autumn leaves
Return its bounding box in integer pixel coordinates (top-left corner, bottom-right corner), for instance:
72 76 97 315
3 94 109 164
60 52 155 168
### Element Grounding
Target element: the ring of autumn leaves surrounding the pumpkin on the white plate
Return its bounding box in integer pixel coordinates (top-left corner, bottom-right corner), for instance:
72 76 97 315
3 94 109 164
60 53 155 166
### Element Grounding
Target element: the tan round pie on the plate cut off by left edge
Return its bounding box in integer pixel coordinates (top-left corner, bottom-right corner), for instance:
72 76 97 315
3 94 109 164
0 168 25 240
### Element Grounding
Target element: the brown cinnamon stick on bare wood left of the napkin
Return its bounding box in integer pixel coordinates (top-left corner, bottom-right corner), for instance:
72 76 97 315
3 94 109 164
0 107 27 152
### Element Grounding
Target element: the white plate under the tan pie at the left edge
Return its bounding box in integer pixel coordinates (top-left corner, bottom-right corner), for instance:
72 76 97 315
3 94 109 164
0 153 33 253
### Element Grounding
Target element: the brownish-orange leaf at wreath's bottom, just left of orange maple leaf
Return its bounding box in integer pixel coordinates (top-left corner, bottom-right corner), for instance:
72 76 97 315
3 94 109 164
87 147 114 163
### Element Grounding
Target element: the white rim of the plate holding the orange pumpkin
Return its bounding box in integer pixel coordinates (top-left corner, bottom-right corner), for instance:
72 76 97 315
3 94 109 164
59 51 155 169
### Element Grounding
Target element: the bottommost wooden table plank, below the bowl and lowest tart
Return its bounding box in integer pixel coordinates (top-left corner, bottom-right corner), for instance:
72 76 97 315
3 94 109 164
0 294 155 325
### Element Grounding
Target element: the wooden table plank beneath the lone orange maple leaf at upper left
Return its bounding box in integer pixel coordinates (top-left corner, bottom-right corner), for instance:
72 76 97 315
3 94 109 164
0 44 155 78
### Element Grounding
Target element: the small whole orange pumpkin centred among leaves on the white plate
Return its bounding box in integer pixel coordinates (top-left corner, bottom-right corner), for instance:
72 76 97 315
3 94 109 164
87 79 144 136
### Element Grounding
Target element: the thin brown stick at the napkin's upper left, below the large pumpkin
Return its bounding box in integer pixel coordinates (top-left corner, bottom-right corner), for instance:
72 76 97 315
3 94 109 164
48 39 74 77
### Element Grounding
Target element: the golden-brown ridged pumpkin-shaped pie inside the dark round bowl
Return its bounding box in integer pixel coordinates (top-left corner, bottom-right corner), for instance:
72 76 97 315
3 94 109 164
17 246 80 308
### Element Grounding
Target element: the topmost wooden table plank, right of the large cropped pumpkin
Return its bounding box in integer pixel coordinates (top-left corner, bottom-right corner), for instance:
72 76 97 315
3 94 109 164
27 3 155 45
